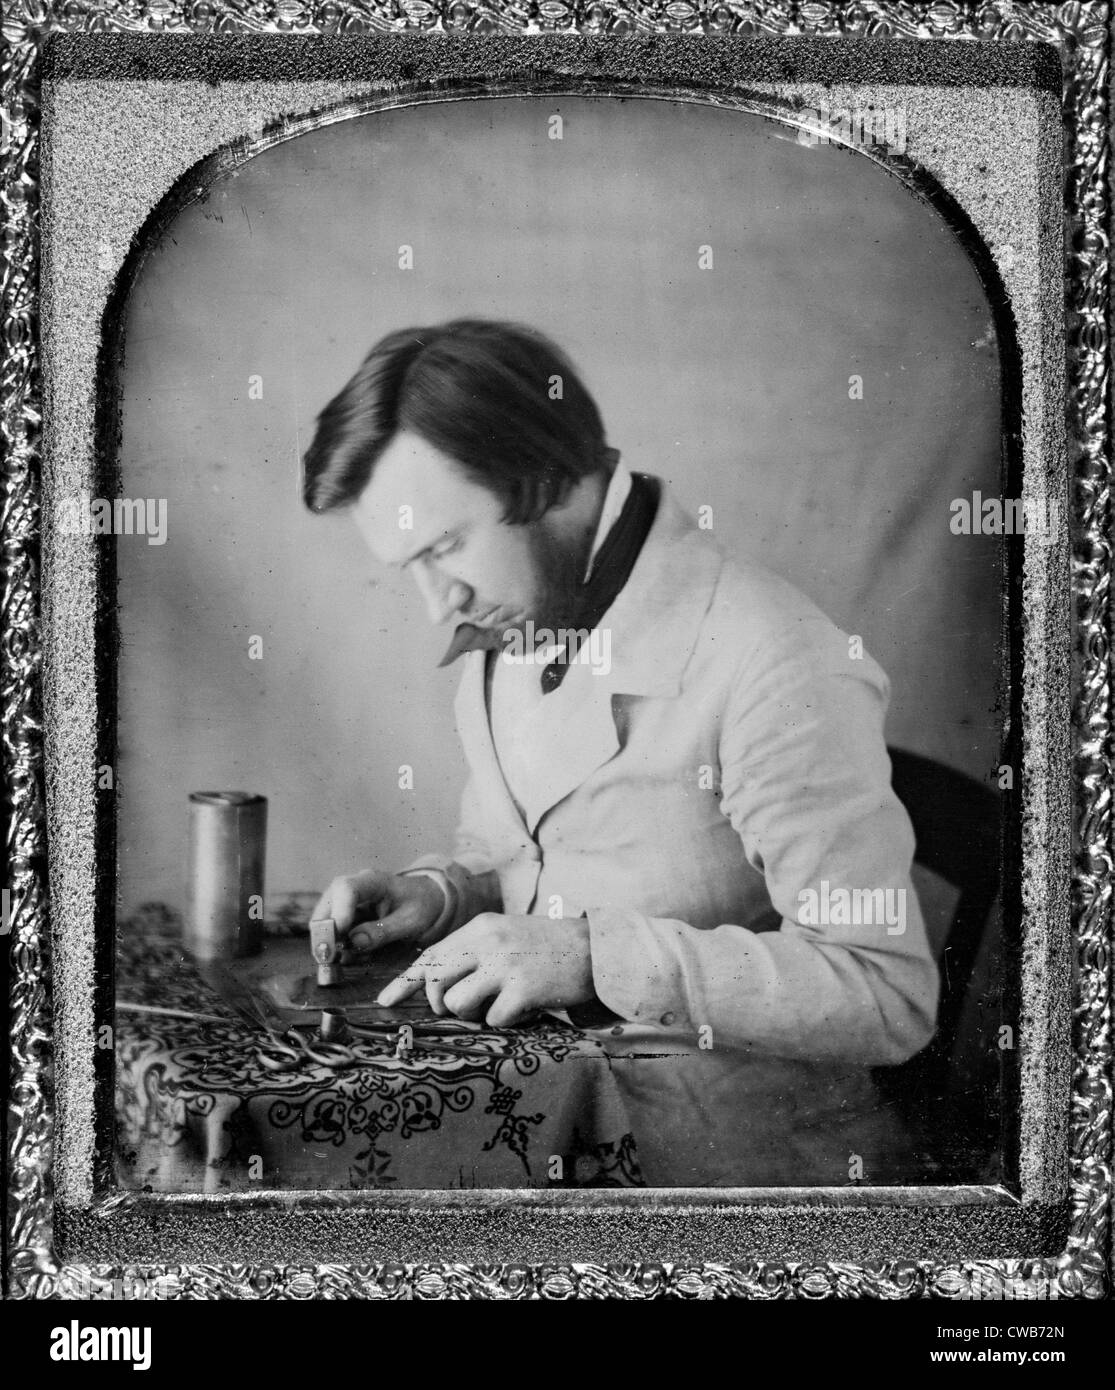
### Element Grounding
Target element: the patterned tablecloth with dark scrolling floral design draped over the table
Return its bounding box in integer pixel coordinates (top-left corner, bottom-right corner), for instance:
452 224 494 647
115 913 644 1193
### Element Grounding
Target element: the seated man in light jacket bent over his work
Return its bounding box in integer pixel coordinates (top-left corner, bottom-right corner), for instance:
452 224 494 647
304 320 937 1186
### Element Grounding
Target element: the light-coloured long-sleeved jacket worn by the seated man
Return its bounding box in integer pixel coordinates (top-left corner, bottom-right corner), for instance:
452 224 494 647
408 487 938 1186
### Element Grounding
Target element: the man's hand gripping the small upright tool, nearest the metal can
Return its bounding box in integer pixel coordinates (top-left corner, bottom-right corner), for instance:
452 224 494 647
313 869 445 951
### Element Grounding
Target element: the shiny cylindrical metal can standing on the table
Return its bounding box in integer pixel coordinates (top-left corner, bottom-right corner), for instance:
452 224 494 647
182 791 267 960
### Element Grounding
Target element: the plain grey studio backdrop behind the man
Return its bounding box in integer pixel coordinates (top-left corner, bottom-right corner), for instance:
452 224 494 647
118 99 1001 910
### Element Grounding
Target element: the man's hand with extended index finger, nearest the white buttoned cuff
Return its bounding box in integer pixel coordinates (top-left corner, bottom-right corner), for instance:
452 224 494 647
377 912 595 1029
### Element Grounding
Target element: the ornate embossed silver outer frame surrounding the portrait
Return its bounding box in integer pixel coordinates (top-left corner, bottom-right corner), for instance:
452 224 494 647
1 0 1112 1298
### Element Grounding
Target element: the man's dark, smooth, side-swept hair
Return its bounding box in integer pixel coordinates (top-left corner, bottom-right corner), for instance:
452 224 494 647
302 318 617 525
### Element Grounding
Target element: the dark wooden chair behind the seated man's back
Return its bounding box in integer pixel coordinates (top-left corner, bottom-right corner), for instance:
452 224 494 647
874 748 1001 1182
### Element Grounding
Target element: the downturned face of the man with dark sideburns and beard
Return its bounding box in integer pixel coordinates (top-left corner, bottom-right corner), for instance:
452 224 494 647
353 431 591 631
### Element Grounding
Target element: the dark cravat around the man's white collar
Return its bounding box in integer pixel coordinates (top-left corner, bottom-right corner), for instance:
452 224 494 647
438 473 659 695
